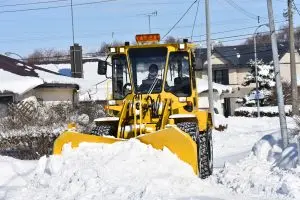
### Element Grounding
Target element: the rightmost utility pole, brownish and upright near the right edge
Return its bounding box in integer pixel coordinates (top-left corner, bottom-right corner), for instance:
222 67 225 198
288 0 299 115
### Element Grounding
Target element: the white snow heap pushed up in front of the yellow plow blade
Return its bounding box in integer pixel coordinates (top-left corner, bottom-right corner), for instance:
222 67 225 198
7 140 241 200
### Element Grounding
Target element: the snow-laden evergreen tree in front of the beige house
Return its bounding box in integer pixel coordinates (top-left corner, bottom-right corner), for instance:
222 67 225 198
237 60 275 106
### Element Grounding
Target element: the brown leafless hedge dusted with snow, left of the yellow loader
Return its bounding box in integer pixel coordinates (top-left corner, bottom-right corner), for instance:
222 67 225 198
0 101 105 159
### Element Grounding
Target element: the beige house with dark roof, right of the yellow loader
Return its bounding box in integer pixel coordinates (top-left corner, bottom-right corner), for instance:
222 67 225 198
195 43 300 115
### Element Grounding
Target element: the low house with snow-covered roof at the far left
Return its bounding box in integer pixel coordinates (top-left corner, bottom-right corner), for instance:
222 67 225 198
0 55 79 104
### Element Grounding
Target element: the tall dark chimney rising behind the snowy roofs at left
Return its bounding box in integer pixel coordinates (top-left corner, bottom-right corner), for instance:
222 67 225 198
70 43 83 78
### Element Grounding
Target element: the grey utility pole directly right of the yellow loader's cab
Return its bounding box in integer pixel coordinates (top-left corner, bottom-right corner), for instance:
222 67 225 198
205 0 215 124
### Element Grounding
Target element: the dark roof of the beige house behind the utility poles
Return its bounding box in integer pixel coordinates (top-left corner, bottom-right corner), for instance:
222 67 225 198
195 42 289 67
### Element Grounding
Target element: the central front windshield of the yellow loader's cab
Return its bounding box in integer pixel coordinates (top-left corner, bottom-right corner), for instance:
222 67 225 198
129 47 168 94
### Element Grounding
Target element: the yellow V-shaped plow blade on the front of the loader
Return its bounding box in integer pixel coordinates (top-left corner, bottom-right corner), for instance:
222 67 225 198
53 127 198 175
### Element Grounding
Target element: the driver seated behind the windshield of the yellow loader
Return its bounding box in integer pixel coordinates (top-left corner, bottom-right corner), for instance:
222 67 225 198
139 64 162 93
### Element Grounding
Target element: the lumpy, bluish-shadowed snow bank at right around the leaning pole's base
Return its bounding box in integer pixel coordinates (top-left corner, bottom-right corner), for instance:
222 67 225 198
214 118 300 199
